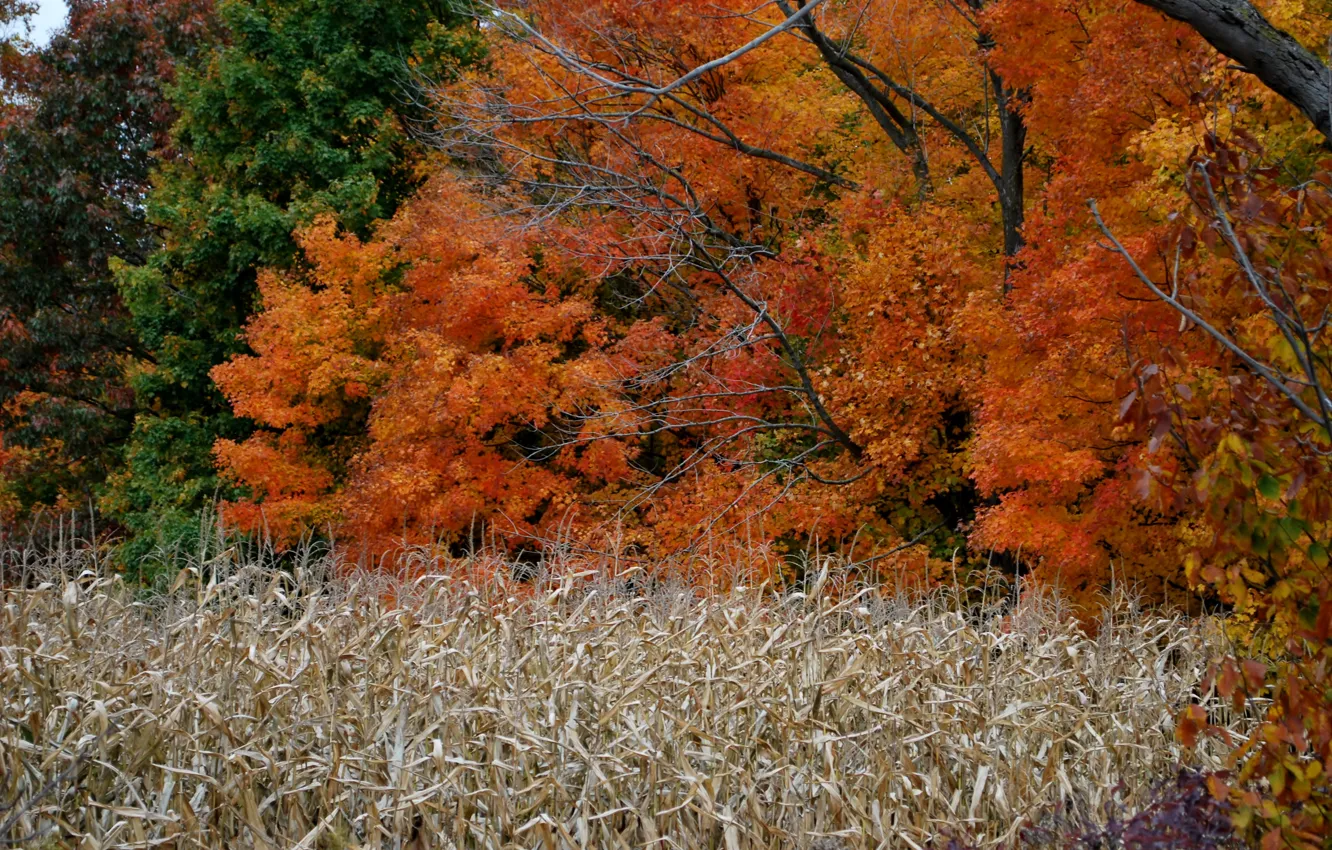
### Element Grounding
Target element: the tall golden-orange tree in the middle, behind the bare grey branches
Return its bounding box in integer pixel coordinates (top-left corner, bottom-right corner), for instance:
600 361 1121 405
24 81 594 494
399 3 1097 575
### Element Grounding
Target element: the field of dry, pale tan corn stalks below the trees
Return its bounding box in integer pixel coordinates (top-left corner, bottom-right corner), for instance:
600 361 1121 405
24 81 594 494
0 556 1246 850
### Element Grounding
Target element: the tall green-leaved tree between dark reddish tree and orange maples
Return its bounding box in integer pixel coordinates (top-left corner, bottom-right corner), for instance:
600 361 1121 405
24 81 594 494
105 0 476 557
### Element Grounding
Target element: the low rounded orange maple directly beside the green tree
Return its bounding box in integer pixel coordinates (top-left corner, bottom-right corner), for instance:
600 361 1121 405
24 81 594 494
213 177 629 549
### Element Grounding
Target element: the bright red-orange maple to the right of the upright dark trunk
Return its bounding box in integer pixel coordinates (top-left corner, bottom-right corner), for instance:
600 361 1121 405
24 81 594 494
967 3 1320 601
